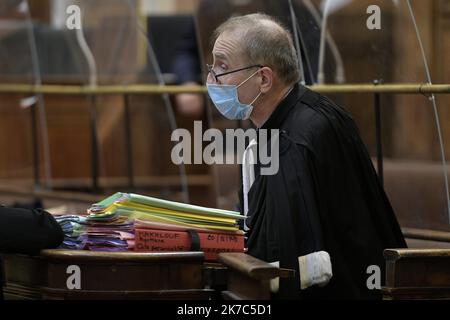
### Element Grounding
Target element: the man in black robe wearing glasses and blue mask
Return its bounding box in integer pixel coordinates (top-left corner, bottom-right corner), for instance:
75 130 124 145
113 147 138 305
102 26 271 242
207 14 406 299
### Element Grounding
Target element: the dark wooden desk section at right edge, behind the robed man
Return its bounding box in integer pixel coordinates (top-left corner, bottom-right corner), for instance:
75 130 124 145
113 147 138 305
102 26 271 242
382 249 450 300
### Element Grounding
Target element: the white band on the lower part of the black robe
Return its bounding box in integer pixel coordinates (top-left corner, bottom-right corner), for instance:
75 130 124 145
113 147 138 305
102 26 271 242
298 251 333 290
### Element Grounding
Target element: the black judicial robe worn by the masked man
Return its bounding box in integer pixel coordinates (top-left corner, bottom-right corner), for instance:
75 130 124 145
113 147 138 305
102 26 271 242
241 85 406 299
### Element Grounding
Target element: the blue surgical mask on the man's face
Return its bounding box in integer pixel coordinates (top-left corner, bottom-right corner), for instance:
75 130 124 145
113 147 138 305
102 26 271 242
206 70 262 120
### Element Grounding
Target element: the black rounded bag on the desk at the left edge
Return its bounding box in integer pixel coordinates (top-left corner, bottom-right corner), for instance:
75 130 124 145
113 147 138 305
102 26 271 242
0 207 64 254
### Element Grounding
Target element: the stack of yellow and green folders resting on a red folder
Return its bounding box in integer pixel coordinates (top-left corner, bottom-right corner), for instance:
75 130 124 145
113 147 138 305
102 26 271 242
86 193 244 260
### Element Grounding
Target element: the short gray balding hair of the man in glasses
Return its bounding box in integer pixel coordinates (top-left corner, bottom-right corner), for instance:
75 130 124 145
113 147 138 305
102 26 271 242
214 13 300 86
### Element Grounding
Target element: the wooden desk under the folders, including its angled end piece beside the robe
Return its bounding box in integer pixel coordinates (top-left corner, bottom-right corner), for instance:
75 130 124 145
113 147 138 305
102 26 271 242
2 250 283 300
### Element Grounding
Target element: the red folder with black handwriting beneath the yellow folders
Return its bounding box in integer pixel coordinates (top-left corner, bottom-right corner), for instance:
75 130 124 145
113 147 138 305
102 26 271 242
134 228 244 261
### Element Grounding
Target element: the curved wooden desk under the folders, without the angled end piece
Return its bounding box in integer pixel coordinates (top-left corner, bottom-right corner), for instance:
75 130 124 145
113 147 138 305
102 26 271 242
3 250 213 299
